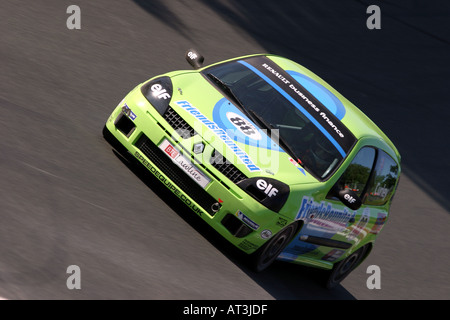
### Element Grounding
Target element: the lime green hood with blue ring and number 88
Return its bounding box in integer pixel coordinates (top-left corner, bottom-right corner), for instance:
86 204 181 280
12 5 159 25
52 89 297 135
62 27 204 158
164 71 317 185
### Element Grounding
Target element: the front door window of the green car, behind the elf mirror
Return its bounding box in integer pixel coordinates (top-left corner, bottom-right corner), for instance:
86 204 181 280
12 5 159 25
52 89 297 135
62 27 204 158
329 147 376 197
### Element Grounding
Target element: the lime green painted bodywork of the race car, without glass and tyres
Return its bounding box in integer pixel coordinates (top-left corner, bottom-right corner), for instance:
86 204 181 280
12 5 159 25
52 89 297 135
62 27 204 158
104 55 400 269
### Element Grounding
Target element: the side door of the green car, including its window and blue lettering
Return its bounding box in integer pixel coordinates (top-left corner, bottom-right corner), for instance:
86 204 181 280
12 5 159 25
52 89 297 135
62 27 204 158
284 147 377 262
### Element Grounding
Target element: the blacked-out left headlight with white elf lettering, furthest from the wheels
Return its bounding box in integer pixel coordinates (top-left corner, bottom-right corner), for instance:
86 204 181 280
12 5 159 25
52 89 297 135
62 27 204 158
141 77 173 115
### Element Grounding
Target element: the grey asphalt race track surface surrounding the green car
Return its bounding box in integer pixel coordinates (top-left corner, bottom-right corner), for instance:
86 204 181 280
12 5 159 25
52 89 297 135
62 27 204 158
0 0 450 300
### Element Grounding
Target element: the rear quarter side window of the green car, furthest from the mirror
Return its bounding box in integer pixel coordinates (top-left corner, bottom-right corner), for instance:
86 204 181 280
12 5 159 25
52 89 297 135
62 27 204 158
364 150 398 206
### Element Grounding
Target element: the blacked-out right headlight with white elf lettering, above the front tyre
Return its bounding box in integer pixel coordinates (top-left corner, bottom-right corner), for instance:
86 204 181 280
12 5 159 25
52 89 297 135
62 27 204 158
237 177 290 212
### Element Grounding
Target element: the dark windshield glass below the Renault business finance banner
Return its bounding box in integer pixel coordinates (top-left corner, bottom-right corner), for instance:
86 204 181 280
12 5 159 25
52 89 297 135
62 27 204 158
203 61 343 179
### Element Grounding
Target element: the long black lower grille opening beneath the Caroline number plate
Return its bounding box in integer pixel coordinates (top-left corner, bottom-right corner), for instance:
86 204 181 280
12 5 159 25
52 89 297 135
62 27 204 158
135 134 217 216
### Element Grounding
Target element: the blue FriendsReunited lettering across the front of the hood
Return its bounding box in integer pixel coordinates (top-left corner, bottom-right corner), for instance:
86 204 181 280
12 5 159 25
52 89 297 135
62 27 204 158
176 100 261 172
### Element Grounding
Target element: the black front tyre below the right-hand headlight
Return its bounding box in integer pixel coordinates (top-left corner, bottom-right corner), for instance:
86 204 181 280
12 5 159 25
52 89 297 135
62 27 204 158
252 224 297 272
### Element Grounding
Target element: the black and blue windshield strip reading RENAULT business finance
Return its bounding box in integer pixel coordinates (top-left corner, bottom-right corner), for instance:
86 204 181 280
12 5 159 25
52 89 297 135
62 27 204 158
239 56 356 157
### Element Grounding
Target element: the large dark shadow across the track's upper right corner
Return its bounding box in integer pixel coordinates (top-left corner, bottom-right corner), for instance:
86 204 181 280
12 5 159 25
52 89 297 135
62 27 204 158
133 0 450 212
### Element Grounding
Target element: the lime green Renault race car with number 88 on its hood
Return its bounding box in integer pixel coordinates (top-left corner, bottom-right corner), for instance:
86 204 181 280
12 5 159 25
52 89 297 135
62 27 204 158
103 50 400 287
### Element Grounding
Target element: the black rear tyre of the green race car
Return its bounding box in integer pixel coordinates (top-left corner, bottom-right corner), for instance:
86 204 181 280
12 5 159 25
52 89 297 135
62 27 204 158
325 245 368 289
